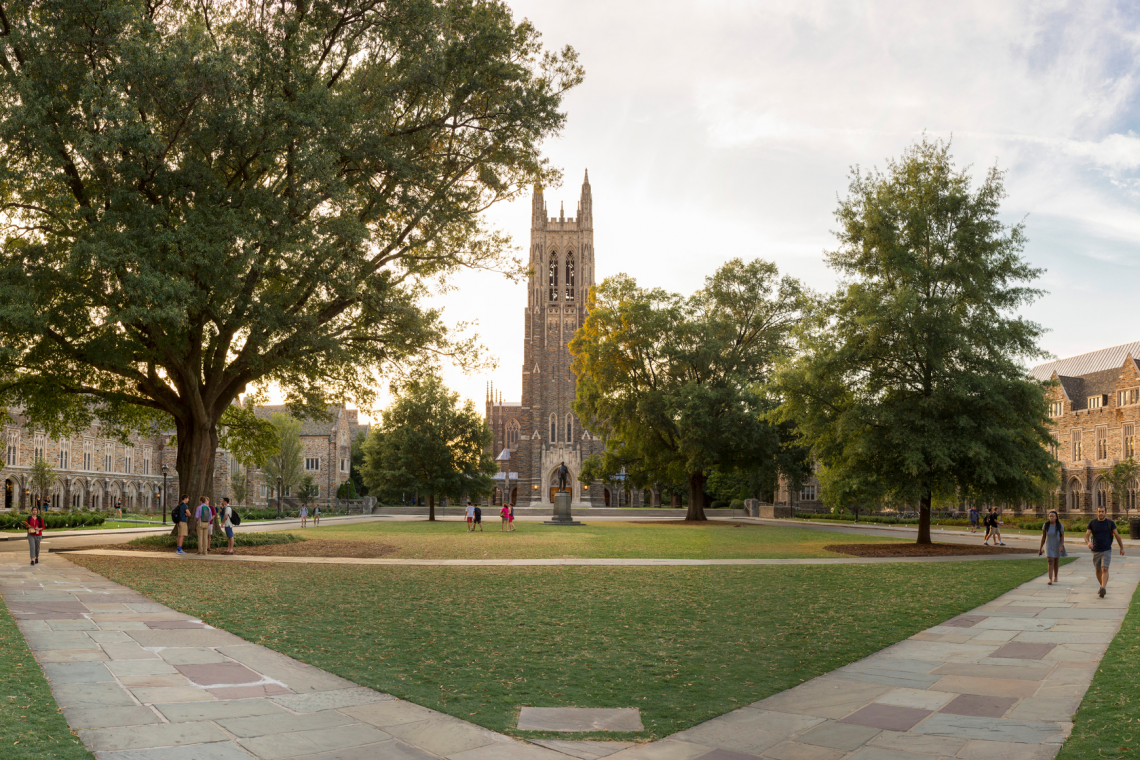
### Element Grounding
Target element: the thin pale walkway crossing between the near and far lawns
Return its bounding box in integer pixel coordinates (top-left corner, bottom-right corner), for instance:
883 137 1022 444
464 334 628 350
66 549 1044 567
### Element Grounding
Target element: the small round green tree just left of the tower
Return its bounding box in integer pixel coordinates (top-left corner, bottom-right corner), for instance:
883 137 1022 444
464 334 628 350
361 373 497 520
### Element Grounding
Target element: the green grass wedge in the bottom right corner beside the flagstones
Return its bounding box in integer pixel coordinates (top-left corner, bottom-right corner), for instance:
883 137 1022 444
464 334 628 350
1057 578 1140 760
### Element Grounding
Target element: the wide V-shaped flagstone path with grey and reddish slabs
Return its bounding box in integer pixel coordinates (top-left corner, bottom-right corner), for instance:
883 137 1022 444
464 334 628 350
0 553 1140 760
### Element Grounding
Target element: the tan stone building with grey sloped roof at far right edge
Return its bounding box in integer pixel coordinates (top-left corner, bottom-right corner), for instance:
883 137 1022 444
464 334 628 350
1031 342 1140 513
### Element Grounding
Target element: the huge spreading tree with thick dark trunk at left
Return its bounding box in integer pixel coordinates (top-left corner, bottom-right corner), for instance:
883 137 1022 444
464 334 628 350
0 0 581 510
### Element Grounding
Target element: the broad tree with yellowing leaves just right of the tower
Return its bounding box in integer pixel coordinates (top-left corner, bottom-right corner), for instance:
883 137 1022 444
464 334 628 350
570 259 805 520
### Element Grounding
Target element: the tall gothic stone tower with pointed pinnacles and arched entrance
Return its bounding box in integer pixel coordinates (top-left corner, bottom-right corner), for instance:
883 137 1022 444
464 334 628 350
487 173 605 507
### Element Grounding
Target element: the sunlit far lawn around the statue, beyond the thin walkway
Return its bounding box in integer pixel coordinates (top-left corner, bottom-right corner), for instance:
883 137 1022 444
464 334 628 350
299 517 906 559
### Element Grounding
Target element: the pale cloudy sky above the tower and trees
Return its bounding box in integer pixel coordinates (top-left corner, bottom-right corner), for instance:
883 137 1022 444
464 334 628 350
408 0 1140 417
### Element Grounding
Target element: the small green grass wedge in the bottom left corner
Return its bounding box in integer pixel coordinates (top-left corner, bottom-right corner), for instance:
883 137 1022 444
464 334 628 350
0 599 93 760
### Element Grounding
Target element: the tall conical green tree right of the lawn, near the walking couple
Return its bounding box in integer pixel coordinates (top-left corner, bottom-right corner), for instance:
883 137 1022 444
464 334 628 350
775 139 1056 544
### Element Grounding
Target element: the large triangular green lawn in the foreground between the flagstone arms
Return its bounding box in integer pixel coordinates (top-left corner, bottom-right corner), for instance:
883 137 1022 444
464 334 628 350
71 555 1044 739
